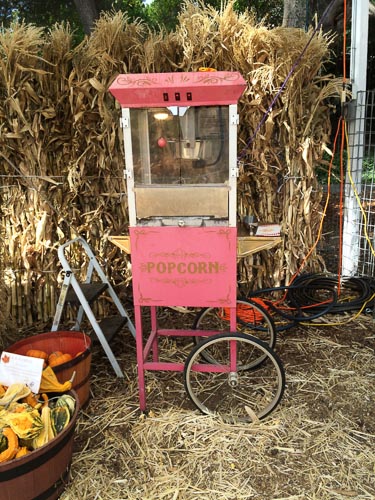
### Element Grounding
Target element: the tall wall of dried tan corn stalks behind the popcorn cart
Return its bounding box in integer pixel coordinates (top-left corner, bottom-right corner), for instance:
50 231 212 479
0 2 337 325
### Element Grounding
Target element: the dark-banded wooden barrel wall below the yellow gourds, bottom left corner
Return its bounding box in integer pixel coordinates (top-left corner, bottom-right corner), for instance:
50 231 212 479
0 391 79 500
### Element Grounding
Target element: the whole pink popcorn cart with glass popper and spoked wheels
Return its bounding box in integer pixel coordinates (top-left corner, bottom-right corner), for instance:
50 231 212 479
109 71 285 421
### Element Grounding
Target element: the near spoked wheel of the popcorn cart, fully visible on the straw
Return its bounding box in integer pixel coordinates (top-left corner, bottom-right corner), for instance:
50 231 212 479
184 333 285 423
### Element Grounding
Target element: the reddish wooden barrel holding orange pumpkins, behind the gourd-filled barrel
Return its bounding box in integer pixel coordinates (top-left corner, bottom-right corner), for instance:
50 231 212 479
5 330 91 407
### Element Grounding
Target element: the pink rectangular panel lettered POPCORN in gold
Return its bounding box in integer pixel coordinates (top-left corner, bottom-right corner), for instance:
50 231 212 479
129 227 237 307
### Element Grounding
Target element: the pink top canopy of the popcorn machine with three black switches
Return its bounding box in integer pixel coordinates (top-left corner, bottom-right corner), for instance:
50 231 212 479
109 71 246 108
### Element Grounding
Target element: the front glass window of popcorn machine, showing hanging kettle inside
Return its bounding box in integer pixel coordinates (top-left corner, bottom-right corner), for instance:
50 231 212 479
130 106 229 185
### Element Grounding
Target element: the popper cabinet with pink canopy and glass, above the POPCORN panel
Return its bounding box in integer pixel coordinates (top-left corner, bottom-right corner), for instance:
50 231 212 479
110 72 245 227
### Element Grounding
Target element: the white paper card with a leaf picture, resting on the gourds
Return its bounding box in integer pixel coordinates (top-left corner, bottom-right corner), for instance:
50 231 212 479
0 351 44 394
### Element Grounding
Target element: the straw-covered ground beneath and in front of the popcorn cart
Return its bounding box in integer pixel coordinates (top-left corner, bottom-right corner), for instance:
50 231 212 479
12 309 375 500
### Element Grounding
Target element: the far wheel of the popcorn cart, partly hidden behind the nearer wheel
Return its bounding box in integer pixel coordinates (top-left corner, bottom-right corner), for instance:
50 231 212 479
193 299 276 370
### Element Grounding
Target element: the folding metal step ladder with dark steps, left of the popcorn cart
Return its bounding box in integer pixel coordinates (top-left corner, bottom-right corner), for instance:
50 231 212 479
52 237 135 377
